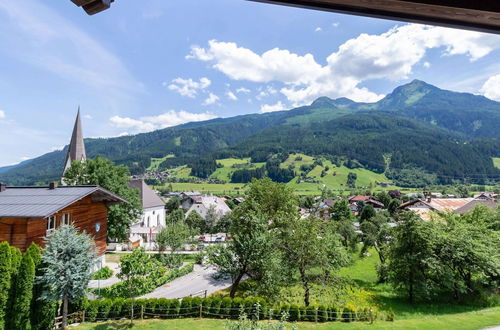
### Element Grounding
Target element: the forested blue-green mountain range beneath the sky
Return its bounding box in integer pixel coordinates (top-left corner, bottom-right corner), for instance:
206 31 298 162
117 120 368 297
0 80 500 185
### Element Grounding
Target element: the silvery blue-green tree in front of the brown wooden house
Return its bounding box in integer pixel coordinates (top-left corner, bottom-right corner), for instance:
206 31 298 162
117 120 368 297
39 225 96 326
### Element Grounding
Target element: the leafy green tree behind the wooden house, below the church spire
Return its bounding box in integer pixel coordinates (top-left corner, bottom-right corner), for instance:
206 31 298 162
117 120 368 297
64 156 142 240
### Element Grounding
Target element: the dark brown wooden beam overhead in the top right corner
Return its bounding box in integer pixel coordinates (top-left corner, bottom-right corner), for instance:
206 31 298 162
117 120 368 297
249 0 500 34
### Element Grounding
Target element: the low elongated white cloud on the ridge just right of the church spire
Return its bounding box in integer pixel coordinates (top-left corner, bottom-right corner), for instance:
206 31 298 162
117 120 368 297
109 110 216 136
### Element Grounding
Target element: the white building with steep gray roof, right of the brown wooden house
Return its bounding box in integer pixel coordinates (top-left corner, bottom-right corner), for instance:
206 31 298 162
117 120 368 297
129 180 166 248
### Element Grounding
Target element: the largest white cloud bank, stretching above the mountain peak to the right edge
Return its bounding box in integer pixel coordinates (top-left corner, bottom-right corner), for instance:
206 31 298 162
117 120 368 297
187 24 500 106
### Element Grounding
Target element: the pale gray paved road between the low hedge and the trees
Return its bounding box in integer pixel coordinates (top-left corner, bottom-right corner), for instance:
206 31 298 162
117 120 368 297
140 265 231 299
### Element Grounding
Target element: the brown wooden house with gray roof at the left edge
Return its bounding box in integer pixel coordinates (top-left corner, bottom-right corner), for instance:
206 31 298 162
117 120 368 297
0 183 127 261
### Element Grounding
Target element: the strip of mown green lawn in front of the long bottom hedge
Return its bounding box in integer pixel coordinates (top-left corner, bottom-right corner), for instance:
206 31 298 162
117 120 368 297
74 307 500 330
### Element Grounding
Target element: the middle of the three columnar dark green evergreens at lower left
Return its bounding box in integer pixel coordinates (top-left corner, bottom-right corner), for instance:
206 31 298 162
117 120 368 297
10 253 35 330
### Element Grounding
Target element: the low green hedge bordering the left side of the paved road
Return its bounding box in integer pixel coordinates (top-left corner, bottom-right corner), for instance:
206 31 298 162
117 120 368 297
92 263 194 299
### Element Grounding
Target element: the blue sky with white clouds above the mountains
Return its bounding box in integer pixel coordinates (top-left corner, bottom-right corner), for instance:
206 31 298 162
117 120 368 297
0 0 500 166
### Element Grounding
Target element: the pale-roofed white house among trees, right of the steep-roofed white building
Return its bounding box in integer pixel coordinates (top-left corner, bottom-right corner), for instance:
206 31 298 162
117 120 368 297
181 193 231 219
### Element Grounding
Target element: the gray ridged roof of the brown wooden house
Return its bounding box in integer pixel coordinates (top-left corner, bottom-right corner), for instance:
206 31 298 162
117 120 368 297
0 186 126 218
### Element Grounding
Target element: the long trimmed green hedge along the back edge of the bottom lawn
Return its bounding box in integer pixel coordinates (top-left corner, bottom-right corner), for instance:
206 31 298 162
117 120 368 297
85 297 372 322
